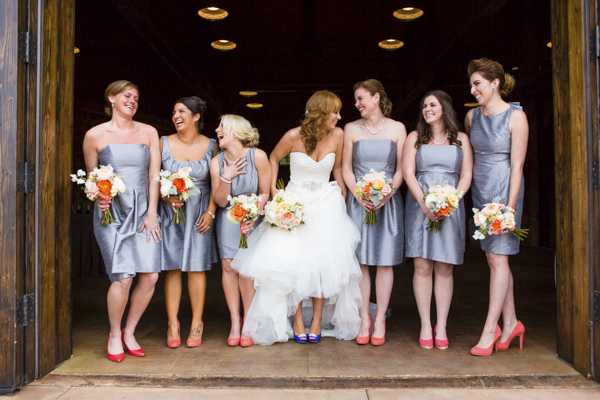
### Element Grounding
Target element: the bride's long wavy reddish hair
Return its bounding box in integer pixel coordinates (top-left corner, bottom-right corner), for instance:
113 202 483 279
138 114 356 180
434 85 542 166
300 90 342 155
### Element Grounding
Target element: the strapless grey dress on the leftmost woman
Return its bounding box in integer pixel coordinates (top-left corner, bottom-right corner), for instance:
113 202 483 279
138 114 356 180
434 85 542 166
94 143 161 282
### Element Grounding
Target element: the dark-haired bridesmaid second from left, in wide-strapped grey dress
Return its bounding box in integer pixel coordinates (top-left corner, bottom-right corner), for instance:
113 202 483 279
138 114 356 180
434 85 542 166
160 96 218 348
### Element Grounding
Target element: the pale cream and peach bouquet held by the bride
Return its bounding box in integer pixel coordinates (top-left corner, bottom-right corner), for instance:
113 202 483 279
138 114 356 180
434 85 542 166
265 180 305 232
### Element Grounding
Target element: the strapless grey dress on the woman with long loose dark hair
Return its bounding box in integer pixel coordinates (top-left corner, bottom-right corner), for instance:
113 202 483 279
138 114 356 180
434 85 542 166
405 145 466 265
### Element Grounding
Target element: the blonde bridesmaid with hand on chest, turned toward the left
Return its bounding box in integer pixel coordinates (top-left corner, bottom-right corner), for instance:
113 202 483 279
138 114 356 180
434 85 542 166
210 114 271 346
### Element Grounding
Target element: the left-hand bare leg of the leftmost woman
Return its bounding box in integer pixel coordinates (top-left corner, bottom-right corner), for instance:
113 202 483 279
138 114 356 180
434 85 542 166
106 278 132 354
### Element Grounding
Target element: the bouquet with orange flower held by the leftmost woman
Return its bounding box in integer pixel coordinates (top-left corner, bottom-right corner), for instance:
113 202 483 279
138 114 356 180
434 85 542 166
71 164 126 225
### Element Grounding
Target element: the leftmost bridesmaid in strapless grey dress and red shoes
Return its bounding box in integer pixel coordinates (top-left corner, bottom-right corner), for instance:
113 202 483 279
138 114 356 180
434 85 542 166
83 80 161 362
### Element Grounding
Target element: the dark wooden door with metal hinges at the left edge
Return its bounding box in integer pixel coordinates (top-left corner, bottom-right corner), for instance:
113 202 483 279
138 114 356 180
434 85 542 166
0 0 74 392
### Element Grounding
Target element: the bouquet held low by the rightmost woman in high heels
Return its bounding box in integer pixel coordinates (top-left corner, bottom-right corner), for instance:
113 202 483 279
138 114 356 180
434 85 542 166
473 197 529 240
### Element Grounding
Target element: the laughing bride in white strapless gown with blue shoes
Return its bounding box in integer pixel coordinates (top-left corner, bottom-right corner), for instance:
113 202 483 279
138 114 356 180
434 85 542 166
231 90 361 345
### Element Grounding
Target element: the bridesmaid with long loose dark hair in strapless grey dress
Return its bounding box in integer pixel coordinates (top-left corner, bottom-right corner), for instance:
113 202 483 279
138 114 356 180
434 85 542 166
402 90 473 349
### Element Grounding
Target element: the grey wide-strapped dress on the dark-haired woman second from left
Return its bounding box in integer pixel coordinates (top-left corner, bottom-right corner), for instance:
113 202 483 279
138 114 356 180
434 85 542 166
160 136 218 272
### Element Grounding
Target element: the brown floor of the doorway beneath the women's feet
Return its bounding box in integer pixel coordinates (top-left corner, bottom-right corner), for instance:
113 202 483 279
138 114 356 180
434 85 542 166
39 243 595 389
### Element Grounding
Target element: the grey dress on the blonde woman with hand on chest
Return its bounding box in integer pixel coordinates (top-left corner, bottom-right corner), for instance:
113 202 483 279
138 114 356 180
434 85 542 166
216 147 260 258
